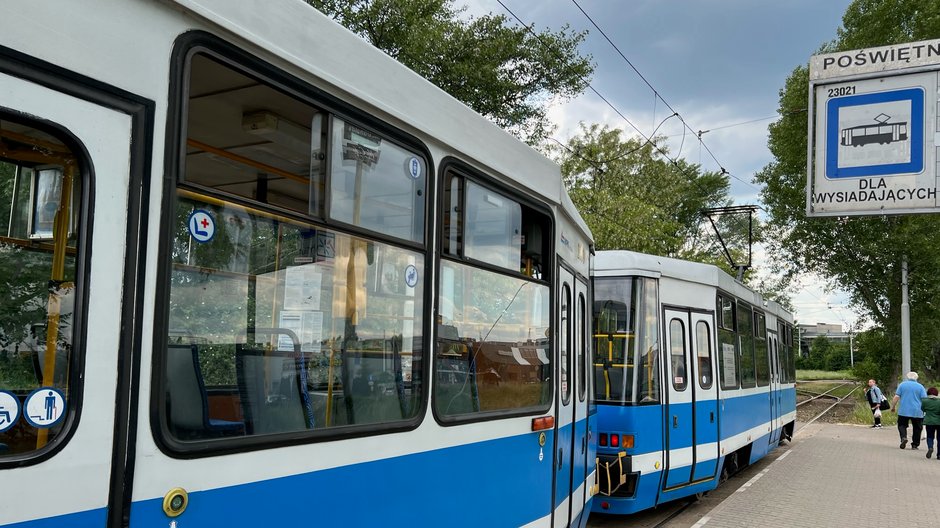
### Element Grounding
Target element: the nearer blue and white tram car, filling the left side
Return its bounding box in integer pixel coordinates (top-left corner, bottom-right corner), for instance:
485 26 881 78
0 0 596 528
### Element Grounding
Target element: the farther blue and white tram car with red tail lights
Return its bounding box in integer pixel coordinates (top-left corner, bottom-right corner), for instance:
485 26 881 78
592 251 796 514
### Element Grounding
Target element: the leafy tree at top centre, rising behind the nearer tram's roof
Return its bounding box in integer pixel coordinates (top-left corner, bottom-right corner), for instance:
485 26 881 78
307 0 594 144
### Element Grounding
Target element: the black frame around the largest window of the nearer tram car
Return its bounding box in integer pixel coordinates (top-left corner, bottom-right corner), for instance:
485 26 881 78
150 31 436 459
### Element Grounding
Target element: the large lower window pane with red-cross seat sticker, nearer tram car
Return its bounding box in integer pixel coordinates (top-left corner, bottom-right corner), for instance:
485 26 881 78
162 193 424 442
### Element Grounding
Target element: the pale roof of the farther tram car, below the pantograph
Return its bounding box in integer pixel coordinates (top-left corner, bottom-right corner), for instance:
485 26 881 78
594 250 793 320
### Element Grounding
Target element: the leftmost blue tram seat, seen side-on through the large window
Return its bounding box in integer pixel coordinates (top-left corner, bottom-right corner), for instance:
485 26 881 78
166 344 245 438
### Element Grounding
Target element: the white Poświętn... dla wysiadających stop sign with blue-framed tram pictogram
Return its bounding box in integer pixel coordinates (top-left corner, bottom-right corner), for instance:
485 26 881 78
806 39 940 216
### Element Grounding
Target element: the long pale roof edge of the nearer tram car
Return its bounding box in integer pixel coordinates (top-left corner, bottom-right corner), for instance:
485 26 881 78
166 0 590 239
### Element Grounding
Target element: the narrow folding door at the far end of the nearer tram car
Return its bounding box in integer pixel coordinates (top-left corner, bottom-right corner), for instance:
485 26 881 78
552 268 584 527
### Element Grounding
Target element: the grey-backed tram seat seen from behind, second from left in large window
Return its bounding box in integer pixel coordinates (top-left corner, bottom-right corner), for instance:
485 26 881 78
235 343 314 434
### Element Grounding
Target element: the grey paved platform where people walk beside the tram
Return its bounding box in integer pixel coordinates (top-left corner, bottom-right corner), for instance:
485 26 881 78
694 424 940 528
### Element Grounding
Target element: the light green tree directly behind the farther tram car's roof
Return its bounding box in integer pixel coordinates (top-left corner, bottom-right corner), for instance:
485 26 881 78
553 123 747 268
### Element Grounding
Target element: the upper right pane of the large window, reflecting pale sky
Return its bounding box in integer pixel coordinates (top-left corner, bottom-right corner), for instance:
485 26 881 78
330 117 427 242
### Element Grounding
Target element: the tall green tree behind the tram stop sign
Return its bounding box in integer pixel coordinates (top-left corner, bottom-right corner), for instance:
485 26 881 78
756 0 940 380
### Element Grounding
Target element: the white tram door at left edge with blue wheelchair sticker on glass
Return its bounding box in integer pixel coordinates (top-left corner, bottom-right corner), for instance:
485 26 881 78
0 64 134 526
